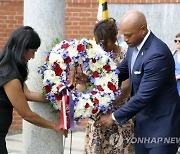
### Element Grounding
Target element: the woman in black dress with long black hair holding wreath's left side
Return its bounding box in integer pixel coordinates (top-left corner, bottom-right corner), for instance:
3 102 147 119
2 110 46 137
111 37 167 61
0 26 67 154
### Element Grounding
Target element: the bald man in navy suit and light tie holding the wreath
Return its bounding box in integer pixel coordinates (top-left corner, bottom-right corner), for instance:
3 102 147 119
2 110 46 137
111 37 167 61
95 10 180 154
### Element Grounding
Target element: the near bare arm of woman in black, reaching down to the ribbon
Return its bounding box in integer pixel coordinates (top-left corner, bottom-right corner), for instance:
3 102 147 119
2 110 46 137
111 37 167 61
4 79 67 136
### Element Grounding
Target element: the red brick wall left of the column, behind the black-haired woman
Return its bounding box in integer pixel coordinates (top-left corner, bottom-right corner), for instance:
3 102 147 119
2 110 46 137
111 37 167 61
0 0 23 130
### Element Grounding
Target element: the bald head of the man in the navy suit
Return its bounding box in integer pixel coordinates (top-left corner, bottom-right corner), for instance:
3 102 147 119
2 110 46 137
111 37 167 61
120 10 148 47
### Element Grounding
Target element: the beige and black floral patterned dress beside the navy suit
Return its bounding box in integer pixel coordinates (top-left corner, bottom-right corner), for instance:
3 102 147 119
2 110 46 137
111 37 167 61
84 47 135 154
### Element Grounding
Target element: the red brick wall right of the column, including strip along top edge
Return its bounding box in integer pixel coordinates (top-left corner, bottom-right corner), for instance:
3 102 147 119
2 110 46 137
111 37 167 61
65 0 180 39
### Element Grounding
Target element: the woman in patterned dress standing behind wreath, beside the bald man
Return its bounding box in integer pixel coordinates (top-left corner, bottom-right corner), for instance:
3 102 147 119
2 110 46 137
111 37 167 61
84 18 134 154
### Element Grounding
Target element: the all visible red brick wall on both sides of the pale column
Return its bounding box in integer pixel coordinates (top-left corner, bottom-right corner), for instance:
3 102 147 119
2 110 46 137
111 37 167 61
0 0 180 130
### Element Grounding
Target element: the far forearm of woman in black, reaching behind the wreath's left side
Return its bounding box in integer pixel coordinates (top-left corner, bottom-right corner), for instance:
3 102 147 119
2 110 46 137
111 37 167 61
23 83 47 102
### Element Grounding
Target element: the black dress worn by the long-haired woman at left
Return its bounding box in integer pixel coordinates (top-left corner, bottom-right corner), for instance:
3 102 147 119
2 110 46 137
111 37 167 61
0 71 19 154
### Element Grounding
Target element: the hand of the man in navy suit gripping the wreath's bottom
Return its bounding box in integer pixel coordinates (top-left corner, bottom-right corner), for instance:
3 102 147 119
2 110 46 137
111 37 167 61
94 114 114 127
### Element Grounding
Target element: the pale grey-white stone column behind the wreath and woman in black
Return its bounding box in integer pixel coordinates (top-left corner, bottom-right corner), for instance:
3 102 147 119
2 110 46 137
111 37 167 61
23 0 65 154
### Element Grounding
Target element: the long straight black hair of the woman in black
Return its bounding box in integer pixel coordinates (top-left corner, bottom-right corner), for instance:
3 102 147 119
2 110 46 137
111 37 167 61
0 26 41 82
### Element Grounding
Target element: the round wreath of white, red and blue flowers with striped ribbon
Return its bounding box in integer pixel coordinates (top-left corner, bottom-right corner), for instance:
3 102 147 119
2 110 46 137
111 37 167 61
38 38 120 129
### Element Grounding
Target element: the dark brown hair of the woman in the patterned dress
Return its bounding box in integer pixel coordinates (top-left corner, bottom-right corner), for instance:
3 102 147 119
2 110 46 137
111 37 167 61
94 18 118 46
